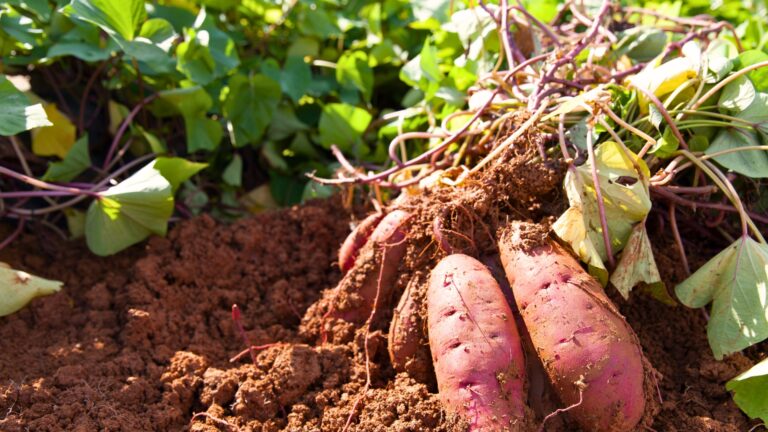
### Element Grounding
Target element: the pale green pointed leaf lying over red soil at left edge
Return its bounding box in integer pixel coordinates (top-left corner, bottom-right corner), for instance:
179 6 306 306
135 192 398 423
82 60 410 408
0 262 63 317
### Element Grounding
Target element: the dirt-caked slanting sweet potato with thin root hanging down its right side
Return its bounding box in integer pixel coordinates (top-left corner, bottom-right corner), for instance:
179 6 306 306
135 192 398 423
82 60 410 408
329 210 410 323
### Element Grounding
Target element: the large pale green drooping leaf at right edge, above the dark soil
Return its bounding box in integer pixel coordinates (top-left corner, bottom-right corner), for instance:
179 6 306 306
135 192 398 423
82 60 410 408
675 237 768 360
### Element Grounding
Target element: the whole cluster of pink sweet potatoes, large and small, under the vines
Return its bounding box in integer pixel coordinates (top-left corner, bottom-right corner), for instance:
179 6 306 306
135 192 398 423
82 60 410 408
316 210 652 431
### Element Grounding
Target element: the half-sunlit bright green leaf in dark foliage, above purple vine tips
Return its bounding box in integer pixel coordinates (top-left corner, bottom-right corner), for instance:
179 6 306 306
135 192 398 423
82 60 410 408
318 103 373 151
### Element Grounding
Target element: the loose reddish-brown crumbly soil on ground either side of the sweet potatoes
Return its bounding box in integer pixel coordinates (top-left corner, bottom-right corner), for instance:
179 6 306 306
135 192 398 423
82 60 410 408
0 200 752 432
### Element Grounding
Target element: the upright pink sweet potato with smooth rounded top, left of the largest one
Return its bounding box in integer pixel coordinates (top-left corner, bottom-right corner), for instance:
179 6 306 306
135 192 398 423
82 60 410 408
427 254 527 431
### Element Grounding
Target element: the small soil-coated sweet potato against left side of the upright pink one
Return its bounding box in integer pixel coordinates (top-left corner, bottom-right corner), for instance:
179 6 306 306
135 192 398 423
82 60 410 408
388 273 432 382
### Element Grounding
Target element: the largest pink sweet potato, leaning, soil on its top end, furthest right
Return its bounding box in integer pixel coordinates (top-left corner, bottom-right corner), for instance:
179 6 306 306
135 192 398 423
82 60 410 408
499 223 646 431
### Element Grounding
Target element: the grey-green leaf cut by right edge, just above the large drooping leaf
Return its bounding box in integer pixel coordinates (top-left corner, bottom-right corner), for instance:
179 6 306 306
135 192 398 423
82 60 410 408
705 128 768 178
